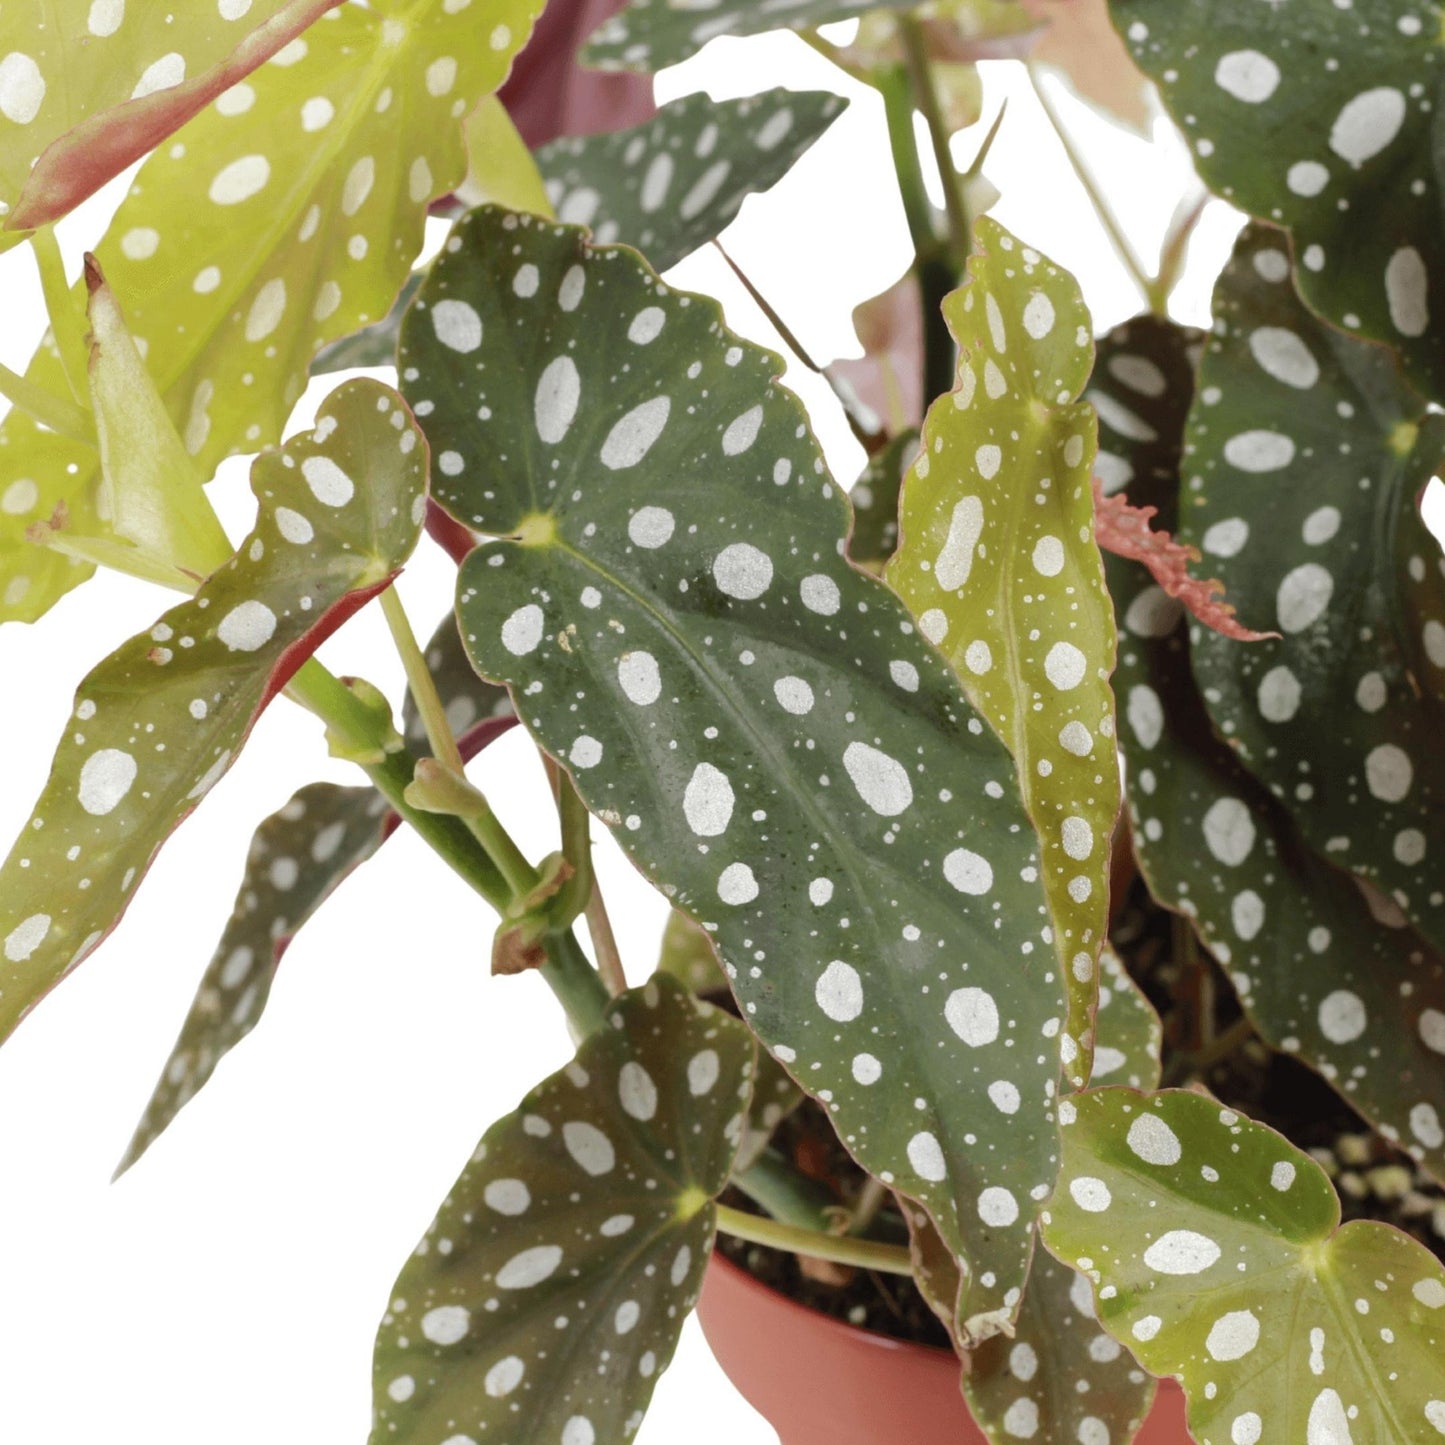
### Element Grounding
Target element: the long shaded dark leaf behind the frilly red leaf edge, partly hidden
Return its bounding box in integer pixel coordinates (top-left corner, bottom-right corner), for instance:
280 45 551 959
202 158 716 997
1090 318 1445 1176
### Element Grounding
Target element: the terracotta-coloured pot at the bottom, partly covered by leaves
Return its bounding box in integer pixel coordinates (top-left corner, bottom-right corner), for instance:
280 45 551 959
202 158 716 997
698 1254 1189 1445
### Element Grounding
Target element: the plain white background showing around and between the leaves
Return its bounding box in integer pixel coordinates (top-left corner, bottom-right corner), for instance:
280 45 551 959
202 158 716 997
0 22 1421 1445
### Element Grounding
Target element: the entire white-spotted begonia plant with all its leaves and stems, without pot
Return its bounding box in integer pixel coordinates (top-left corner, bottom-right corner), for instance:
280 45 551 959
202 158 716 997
0 0 1445 1445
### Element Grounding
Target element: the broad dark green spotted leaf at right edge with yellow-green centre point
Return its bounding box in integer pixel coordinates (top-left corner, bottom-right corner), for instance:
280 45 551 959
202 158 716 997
1162 227 1445 948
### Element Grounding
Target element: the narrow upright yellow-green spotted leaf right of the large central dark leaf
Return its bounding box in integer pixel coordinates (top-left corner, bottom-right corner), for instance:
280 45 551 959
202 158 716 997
887 217 1118 1087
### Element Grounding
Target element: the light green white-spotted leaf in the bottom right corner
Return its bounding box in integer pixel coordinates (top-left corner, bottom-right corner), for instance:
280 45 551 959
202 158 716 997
1043 1088 1445 1445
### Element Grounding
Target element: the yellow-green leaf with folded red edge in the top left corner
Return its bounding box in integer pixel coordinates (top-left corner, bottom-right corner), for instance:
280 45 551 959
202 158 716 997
0 0 338 234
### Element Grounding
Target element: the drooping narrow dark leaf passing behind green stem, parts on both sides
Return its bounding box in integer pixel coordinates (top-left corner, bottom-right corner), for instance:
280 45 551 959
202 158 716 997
117 613 514 1173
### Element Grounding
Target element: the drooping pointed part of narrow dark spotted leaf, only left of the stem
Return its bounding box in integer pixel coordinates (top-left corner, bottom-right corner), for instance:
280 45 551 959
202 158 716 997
116 783 396 1173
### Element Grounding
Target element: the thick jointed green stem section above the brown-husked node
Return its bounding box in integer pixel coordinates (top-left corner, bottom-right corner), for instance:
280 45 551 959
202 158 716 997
286 657 512 912
